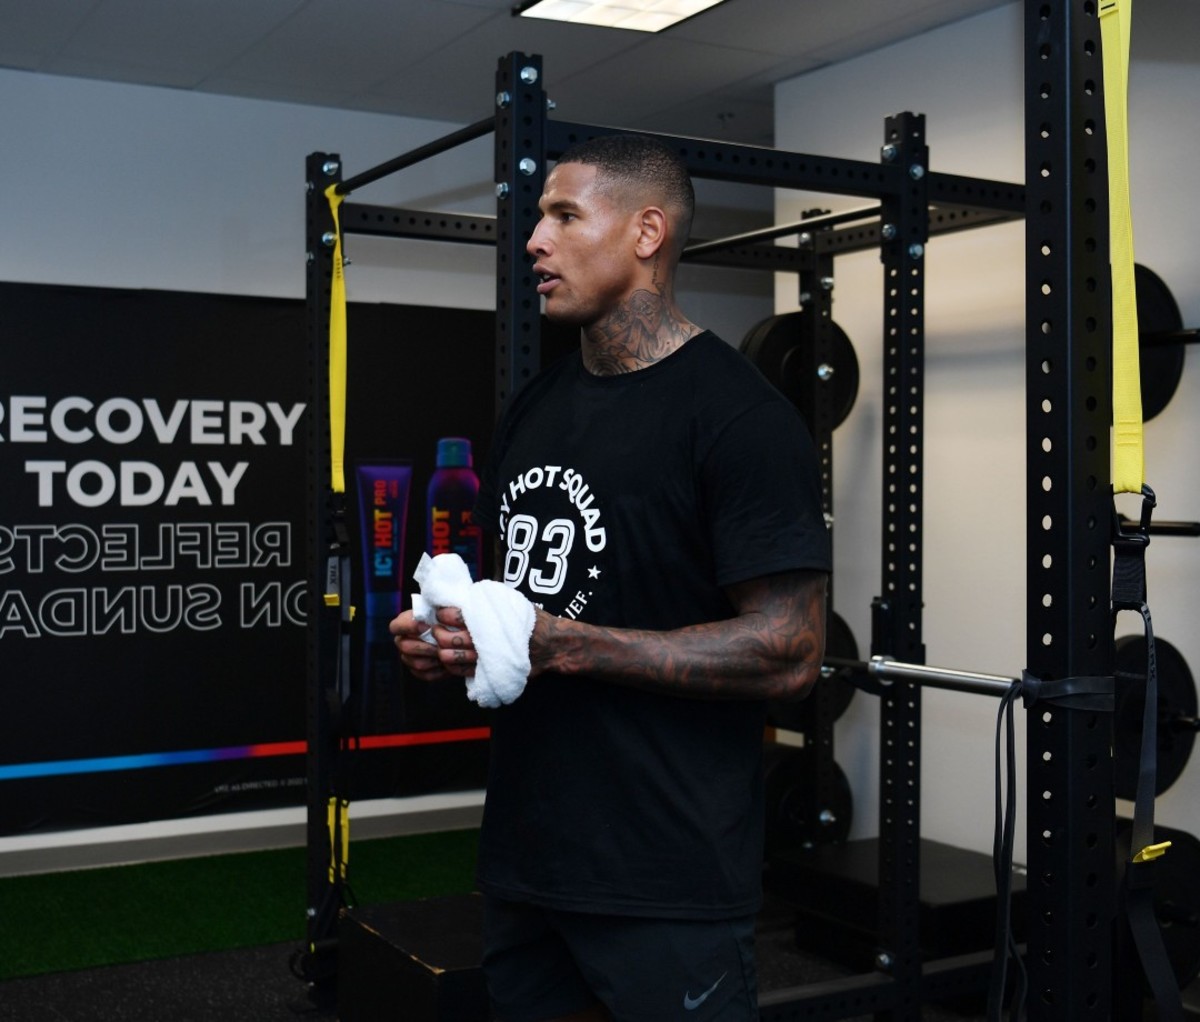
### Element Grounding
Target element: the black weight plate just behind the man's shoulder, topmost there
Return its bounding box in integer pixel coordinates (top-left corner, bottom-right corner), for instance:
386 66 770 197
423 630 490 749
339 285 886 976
742 312 858 428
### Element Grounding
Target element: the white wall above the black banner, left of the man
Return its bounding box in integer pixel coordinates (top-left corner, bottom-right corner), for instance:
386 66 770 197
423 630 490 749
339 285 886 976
0 70 772 339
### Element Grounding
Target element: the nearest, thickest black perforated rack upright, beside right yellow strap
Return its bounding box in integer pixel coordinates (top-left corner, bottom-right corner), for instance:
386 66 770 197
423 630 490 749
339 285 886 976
1025 0 1113 1022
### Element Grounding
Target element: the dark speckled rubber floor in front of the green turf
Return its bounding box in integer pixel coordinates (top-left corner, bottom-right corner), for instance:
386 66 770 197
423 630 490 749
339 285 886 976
0 910 984 1022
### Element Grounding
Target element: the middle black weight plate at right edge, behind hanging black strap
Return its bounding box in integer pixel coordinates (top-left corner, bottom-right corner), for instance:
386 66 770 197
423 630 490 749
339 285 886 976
1112 636 1196 800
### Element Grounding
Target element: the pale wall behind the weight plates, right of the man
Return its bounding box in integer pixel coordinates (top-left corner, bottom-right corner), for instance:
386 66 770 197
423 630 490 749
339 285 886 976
775 0 1200 858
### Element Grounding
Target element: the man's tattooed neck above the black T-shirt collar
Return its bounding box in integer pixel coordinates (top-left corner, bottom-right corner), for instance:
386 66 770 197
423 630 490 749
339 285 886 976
583 290 701 377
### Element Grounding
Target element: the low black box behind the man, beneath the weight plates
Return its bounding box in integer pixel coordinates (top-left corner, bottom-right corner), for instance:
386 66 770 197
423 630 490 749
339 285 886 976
766 837 1025 969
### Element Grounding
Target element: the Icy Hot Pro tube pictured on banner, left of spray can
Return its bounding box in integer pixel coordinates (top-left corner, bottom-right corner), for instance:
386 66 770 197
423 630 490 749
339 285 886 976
355 462 413 618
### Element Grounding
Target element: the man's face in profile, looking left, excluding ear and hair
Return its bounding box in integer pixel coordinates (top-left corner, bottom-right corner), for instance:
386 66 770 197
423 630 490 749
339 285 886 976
526 163 638 326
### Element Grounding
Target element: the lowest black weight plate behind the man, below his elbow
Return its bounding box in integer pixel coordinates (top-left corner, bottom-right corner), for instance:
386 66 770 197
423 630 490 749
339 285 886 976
763 741 854 854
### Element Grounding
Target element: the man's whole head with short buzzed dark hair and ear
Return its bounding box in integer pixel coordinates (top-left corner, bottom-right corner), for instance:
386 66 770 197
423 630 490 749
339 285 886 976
526 136 695 326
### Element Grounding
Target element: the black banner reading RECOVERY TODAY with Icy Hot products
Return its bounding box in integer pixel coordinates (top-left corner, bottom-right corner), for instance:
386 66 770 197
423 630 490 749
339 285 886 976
0 284 574 834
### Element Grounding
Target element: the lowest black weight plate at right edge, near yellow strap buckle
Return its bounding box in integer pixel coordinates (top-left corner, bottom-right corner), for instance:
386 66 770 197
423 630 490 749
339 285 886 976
1116 819 1200 996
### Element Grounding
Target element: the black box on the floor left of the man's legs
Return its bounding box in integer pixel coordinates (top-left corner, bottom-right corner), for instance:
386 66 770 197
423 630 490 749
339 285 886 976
337 895 490 1022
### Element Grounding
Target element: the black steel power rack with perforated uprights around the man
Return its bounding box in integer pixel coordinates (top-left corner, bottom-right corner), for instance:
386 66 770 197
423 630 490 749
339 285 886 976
306 0 1115 1022
